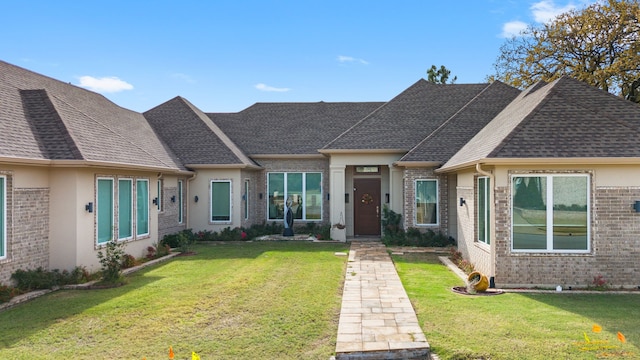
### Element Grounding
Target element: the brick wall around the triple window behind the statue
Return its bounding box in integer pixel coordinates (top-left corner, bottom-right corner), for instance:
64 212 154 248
252 159 330 226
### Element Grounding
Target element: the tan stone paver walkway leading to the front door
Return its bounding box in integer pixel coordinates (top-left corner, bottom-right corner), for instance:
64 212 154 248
336 241 430 360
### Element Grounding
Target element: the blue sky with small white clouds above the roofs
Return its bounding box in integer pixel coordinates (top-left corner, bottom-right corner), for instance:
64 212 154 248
0 0 594 112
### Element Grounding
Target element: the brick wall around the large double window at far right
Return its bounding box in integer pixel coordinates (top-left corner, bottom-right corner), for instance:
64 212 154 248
495 187 640 288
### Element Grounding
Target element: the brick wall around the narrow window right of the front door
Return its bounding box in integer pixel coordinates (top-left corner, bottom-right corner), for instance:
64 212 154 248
403 168 449 236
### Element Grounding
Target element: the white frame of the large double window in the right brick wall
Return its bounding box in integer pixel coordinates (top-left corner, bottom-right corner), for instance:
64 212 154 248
509 173 592 254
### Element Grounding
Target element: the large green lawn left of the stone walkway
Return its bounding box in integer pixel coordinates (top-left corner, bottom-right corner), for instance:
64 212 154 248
0 242 348 360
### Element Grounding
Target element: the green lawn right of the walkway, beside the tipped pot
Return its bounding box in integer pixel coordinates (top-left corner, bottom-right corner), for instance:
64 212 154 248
394 254 640 360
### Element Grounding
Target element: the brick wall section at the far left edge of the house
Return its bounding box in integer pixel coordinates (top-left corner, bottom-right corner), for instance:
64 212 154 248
0 181 49 285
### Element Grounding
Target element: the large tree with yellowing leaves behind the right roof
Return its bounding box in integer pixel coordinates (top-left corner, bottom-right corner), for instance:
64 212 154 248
488 0 640 102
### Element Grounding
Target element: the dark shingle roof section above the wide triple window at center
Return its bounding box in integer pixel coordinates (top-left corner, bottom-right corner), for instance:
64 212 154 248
208 101 384 155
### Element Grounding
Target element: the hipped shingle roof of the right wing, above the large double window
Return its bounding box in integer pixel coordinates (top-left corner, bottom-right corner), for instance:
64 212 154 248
443 77 640 169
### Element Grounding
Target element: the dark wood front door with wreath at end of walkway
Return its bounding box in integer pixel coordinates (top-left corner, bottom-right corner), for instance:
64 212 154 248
353 179 381 236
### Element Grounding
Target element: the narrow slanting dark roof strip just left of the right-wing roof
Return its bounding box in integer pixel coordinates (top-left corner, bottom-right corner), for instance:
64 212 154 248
400 81 520 163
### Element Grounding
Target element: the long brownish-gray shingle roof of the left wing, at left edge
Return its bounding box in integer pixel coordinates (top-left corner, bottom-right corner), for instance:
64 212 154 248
0 61 184 170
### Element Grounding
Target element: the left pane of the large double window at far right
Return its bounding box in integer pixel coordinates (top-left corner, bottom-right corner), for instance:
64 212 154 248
512 177 547 250
